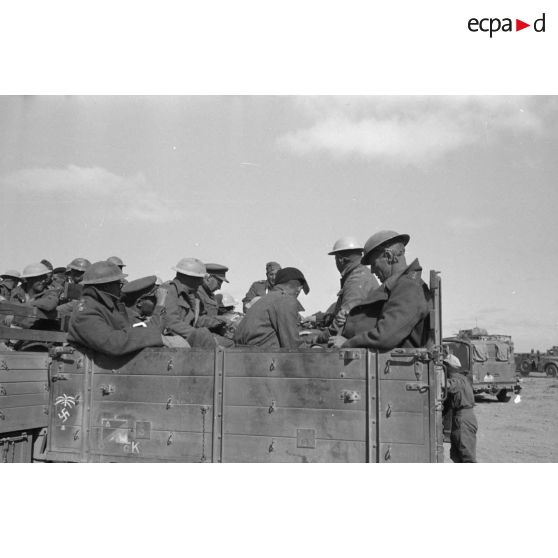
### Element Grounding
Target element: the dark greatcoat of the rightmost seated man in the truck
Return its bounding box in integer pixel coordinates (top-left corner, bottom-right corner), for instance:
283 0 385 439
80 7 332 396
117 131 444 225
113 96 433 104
343 260 430 351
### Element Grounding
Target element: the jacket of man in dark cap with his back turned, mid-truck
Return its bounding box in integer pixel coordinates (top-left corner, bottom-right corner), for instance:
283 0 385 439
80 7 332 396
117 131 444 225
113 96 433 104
234 285 302 350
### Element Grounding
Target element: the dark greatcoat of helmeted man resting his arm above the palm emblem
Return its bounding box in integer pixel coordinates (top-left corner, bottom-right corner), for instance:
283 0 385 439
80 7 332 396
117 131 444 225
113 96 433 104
68 285 163 356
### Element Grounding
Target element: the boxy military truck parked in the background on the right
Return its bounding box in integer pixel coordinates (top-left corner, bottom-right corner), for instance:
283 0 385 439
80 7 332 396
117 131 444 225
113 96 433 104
443 327 521 402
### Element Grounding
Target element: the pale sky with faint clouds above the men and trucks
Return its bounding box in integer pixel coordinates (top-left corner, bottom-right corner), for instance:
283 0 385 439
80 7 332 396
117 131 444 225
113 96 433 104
0 95 558 351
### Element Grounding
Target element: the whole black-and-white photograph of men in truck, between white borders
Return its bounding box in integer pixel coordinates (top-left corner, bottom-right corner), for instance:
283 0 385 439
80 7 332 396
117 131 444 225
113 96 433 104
0 95 558 463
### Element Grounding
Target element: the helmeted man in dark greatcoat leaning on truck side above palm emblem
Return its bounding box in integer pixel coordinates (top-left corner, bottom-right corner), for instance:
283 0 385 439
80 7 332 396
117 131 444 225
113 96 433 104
68 261 164 356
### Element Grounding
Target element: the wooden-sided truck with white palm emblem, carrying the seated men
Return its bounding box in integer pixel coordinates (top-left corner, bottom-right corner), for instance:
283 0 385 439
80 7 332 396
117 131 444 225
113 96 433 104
0 272 446 463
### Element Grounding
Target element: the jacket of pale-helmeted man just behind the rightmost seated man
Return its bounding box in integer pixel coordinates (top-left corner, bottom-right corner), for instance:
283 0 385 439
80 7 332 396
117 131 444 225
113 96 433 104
328 262 379 335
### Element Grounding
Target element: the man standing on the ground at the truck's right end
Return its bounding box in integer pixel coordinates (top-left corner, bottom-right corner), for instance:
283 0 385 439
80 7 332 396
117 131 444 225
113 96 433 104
444 355 478 463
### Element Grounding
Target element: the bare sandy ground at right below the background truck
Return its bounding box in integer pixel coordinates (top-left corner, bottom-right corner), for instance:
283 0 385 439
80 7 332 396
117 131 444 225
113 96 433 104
444 373 558 463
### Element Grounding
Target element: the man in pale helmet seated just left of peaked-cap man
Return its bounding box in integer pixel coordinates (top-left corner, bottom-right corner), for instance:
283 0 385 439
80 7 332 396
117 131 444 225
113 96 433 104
161 258 223 349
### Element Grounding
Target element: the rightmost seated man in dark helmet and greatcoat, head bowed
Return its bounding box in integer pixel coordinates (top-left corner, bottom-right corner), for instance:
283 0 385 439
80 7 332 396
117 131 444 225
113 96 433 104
333 231 430 351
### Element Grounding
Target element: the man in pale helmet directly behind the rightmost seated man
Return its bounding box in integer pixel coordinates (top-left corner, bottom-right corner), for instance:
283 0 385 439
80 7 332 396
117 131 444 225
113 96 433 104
308 236 379 343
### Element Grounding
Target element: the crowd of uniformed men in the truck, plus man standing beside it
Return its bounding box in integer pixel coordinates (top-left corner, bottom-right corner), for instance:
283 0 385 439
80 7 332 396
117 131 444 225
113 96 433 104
0 230 482 461
